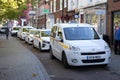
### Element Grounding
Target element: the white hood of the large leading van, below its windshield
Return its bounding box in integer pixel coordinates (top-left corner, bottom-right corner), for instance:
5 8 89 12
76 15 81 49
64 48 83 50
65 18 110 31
67 39 107 51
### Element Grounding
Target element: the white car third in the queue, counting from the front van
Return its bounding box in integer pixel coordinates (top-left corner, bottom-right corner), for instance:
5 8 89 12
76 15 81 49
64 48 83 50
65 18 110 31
25 29 38 44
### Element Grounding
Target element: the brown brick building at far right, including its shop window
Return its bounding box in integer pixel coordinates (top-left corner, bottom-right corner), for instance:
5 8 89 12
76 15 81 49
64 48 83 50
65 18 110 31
107 0 120 44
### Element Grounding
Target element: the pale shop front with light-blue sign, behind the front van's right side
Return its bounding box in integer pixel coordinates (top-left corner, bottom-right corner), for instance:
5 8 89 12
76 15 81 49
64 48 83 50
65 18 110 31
83 4 106 35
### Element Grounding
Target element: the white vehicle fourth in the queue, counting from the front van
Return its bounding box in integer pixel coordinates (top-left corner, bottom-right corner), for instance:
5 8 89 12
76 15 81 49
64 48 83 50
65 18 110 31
17 26 34 40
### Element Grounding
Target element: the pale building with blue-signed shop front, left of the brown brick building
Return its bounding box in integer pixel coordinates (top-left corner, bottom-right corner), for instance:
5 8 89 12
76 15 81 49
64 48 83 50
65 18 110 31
78 0 107 34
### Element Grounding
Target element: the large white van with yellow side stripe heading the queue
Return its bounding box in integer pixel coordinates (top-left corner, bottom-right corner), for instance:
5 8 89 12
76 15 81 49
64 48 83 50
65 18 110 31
50 23 111 68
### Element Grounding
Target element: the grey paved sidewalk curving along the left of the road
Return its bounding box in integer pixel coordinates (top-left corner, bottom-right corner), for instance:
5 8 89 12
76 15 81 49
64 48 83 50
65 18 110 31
0 36 50 80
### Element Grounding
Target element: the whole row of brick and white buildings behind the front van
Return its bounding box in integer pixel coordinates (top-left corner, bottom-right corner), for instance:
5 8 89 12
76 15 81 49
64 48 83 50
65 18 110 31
36 0 120 41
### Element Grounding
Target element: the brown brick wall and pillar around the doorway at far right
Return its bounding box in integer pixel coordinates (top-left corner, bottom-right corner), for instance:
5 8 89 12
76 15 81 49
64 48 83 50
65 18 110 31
107 0 120 42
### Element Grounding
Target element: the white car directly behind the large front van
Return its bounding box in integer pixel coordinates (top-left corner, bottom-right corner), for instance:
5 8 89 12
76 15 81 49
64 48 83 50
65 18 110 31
33 29 51 51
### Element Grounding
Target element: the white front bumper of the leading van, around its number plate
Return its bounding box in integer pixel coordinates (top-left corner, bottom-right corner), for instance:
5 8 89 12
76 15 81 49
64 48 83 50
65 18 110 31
66 50 111 66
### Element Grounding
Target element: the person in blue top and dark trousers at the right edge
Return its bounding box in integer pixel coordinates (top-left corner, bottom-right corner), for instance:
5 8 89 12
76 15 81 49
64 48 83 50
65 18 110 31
114 27 120 54
